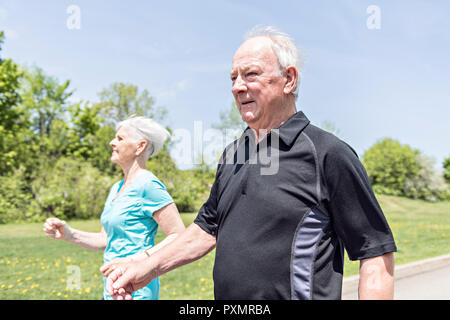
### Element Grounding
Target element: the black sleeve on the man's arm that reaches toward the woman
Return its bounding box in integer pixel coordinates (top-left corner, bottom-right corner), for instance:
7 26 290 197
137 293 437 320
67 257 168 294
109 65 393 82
194 165 220 236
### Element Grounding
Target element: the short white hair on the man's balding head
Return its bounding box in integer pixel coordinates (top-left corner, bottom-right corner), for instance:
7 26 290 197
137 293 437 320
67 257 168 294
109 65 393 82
244 25 303 98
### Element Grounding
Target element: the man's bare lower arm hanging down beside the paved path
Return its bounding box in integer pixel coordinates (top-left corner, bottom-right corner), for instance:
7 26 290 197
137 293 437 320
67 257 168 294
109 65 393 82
358 252 394 300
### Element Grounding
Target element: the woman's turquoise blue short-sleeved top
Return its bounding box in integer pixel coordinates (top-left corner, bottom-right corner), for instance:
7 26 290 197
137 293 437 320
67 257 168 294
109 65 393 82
100 171 173 300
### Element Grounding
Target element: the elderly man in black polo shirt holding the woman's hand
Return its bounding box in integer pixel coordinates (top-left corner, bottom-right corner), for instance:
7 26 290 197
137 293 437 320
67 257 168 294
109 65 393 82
102 27 396 299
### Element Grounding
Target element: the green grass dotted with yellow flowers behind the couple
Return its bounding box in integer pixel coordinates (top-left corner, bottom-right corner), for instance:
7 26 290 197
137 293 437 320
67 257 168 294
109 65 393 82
0 196 450 300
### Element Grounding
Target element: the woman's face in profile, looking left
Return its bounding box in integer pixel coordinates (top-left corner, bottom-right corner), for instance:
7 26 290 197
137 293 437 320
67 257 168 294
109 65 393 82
109 127 138 166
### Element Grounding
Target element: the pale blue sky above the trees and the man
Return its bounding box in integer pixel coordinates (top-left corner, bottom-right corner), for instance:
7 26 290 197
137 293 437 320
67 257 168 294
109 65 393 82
0 0 450 166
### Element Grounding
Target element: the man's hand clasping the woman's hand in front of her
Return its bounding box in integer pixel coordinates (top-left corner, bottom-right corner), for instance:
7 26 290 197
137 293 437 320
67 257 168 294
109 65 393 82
102 260 156 300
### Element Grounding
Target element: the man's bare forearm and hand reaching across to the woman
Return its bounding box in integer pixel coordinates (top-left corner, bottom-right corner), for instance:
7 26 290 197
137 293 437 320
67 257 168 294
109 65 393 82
106 223 216 300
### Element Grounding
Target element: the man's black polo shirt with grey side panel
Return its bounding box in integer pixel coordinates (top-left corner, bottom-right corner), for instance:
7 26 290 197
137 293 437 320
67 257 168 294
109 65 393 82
195 112 396 300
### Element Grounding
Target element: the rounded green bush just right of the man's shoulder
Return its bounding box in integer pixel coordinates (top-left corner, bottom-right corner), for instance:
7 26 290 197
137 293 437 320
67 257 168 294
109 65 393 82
363 138 420 195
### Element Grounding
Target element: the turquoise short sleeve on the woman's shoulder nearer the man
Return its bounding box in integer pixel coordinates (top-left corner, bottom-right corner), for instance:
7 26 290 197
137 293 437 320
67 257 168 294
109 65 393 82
142 177 174 217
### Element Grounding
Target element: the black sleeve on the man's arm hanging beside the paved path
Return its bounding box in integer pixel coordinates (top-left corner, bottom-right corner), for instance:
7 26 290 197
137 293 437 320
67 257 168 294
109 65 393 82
324 141 397 260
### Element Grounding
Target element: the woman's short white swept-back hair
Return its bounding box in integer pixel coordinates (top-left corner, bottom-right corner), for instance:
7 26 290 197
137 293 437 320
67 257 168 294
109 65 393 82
116 116 170 161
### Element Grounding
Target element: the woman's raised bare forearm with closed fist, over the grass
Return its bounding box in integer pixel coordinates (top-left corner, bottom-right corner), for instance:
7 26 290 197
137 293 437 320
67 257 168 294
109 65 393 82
44 218 107 251
